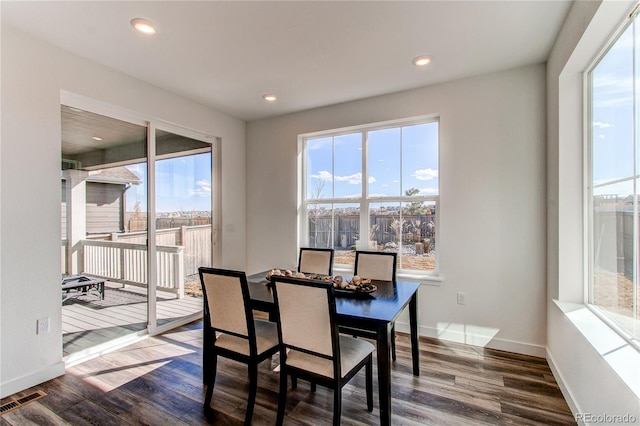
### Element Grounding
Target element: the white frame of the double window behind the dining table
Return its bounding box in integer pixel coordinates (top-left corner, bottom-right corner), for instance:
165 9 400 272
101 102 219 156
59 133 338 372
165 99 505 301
298 115 441 281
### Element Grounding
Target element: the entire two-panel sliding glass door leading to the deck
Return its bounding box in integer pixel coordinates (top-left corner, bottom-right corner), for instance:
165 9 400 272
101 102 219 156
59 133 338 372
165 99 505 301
61 106 215 356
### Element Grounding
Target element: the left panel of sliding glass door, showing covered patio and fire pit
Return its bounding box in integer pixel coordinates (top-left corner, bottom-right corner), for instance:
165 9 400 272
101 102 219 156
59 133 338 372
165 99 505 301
61 106 149 356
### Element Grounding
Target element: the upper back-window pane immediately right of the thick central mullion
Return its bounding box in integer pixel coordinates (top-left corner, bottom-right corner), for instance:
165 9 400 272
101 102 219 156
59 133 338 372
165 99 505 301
367 127 401 197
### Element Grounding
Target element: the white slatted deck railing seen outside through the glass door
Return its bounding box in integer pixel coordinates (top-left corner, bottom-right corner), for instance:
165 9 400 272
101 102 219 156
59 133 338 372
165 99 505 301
80 240 184 298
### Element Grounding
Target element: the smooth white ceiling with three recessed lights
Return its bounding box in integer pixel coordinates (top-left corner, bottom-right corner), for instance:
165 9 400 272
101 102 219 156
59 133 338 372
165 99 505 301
0 0 571 121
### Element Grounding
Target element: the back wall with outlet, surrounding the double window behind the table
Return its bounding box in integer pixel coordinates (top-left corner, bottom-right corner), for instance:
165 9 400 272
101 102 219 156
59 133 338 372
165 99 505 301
247 65 546 356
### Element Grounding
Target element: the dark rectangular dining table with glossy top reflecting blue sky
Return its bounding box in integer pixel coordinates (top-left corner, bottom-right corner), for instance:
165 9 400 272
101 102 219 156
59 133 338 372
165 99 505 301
247 271 420 426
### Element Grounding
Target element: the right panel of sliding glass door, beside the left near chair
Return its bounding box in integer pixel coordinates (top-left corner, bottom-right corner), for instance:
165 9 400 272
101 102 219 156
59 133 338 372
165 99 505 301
154 129 213 327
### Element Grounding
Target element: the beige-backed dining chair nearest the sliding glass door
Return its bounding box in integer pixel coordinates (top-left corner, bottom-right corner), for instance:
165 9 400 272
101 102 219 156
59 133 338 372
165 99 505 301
198 267 280 425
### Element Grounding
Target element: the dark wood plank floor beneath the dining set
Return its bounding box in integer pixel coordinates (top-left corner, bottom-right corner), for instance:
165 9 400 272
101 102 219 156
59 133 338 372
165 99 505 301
0 321 576 426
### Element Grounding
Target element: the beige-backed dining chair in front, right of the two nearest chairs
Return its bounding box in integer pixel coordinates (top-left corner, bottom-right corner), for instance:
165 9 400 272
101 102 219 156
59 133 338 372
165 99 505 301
271 276 375 425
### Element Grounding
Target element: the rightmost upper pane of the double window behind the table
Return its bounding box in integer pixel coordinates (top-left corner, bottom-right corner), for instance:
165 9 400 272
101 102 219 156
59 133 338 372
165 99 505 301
402 122 439 195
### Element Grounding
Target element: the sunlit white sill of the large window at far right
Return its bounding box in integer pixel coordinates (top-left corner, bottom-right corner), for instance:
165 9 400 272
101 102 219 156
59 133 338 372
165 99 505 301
554 300 640 398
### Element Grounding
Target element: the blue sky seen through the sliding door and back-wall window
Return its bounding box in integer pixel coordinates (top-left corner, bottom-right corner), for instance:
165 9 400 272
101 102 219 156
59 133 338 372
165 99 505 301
121 122 439 213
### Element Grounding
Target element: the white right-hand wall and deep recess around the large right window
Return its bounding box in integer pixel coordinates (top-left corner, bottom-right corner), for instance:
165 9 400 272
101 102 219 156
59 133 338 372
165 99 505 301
547 1 640 424
